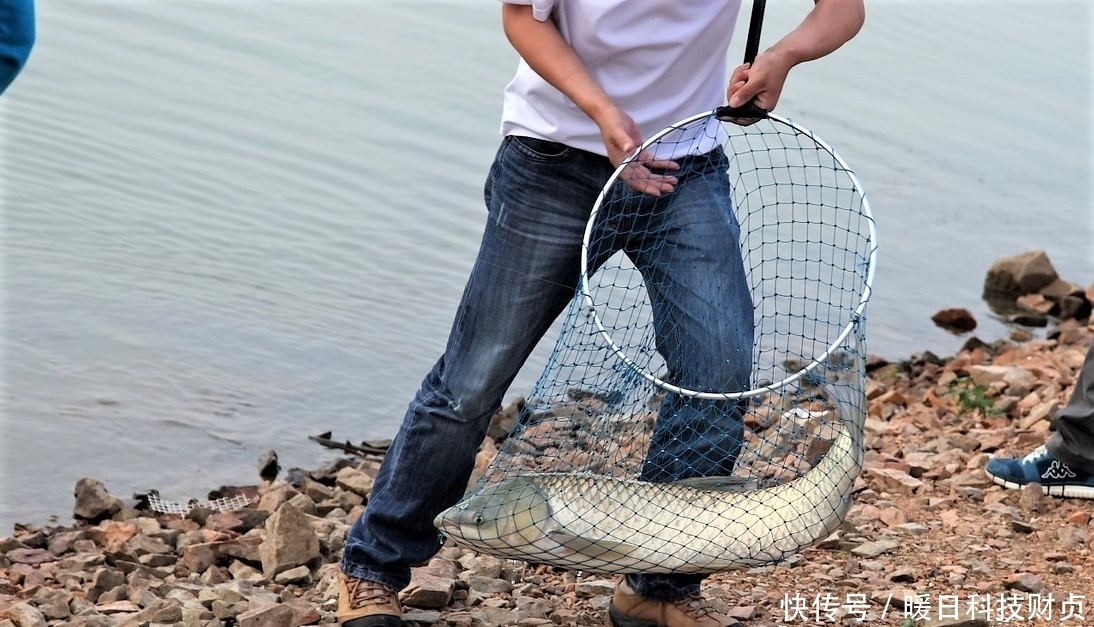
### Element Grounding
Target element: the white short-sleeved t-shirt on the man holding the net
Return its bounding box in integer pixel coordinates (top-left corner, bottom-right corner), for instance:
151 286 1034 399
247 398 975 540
501 0 741 156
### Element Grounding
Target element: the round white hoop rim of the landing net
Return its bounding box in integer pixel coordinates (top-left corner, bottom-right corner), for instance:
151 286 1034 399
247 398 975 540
578 109 877 399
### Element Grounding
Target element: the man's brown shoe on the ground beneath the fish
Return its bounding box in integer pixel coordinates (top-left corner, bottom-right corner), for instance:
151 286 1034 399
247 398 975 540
608 578 744 627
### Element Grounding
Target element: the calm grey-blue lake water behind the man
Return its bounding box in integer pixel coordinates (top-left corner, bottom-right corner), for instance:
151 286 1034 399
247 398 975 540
0 0 1094 527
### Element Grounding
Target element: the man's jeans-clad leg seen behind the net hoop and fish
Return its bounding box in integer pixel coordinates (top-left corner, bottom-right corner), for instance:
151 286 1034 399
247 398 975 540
626 152 754 602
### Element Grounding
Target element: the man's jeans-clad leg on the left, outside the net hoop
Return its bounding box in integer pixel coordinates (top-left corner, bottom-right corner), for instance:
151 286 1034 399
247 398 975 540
342 138 610 590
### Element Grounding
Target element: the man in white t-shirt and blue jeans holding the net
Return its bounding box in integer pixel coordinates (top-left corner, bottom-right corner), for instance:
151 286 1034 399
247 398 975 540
338 0 864 627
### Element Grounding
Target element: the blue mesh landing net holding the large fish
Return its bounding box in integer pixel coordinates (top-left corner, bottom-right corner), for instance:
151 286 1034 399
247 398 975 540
438 115 875 572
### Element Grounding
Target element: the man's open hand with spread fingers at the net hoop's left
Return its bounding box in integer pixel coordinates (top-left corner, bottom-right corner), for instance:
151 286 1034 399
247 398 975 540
596 107 679 196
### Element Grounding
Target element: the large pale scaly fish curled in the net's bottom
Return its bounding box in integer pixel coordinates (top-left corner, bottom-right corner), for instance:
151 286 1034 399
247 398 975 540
433 385 866 573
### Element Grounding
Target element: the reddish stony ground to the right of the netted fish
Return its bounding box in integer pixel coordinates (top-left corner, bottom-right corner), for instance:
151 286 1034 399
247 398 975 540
687 324 1094 625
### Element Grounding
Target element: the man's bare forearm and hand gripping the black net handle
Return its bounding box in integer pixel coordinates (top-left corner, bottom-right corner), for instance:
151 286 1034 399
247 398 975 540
729 0 866 111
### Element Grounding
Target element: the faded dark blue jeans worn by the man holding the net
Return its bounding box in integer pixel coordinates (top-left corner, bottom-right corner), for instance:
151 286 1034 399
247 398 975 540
341 137 753 600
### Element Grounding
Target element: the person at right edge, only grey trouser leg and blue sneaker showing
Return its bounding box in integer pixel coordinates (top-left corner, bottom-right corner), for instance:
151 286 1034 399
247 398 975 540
985 344 1094 499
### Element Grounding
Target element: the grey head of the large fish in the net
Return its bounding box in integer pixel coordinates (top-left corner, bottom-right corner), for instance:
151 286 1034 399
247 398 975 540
433 477 552 549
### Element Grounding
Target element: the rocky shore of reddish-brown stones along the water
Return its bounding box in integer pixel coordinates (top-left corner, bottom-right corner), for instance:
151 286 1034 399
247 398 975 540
0 254 1094 627
